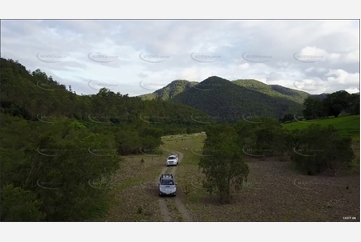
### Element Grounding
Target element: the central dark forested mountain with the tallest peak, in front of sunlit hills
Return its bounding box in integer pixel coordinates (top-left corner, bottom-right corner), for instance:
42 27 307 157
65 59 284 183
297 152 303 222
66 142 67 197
169 76 303 122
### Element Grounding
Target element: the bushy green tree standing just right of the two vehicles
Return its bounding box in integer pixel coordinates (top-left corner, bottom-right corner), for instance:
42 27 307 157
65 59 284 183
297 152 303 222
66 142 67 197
199 125 249 204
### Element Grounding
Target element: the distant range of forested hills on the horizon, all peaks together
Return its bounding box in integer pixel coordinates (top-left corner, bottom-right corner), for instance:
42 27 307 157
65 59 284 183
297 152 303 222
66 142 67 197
139 76 310 122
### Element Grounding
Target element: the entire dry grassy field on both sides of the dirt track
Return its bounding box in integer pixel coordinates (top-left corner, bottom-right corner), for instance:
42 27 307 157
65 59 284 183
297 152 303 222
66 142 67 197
100 134 360 222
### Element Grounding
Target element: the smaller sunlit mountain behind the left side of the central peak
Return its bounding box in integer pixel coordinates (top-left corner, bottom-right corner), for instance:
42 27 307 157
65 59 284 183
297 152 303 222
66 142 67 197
139 80 198 100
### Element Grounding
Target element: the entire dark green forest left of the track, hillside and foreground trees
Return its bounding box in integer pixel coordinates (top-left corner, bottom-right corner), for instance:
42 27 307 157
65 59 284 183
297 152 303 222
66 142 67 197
0 59 210 222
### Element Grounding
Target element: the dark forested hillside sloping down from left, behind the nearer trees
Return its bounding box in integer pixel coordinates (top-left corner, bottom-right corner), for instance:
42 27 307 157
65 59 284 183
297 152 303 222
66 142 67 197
0 58 207 133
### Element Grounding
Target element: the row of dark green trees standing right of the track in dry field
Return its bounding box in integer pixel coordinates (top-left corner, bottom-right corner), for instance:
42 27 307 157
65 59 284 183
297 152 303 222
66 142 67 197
199 117 354 203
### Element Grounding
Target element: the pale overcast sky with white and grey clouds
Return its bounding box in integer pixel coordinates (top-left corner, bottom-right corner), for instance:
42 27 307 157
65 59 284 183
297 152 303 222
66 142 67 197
1 20 360 96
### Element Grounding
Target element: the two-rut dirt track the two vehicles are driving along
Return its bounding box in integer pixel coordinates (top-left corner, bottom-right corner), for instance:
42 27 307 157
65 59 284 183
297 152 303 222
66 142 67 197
155 146 192 222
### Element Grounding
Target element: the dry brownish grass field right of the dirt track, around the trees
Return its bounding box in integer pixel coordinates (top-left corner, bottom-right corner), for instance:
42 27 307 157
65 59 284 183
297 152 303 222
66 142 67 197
165 133 360 221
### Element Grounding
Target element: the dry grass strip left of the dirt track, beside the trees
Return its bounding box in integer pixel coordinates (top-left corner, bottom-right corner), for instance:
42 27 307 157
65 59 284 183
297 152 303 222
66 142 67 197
100 155 165 222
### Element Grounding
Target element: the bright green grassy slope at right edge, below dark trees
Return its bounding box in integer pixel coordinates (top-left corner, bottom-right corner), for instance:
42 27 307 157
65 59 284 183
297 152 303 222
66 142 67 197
283 115 360 141
